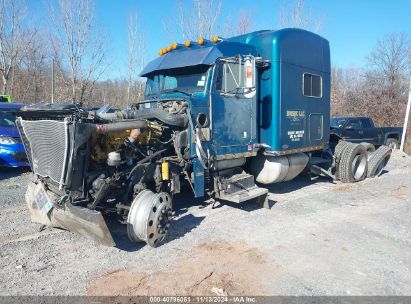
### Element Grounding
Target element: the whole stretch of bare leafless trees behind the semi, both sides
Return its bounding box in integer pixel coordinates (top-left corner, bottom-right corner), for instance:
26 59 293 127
0 0 411 126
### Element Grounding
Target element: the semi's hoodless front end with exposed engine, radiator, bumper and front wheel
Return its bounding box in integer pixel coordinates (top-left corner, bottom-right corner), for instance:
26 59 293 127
17 98 192 246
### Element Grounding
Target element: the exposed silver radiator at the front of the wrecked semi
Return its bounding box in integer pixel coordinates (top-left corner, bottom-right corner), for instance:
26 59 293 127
20 120 69 185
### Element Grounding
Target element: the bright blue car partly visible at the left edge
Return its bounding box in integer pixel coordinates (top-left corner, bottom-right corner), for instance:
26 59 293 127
0 103 29 167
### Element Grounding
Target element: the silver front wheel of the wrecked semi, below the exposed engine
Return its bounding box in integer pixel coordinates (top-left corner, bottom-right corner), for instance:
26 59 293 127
127 190 172 247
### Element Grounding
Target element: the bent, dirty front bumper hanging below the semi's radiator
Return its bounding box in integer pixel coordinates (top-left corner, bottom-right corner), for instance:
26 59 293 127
26 182 116 246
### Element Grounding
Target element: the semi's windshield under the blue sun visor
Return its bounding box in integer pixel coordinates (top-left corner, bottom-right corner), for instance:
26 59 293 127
145 65 210 96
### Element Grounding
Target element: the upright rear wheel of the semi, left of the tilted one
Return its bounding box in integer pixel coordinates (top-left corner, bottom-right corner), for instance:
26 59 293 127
338 144 368 183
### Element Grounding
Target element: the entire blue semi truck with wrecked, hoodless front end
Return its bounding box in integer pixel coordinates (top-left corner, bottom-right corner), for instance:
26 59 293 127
17 29 390 246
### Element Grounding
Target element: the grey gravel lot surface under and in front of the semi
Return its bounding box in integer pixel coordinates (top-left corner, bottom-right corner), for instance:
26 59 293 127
0 152 411 295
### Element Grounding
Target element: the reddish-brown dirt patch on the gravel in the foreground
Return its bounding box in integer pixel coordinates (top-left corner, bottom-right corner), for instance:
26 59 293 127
86 241 278 296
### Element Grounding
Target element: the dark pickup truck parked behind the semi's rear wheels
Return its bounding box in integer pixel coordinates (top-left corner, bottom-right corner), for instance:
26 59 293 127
330 116 402 149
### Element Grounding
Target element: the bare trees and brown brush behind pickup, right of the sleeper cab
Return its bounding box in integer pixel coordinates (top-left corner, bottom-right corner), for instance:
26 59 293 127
331 34 411 126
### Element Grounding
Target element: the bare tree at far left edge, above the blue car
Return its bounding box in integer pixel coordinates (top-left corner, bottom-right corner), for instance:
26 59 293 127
0 0 29 94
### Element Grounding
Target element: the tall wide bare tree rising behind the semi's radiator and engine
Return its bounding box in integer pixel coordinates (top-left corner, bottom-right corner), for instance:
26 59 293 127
51 0 107 103
